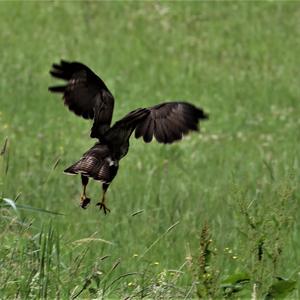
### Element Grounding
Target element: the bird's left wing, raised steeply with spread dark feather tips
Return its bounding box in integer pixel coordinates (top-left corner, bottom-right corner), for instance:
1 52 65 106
49 60 114 139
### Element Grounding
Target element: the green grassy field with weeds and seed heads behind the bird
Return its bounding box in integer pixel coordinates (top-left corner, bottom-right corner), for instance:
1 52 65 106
0 1 300 299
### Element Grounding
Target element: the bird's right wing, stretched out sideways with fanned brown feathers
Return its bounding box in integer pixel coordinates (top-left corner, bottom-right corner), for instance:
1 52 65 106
108 102 208 144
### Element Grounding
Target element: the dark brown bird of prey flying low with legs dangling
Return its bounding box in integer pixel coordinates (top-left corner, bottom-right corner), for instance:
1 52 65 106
49 60 208 214
